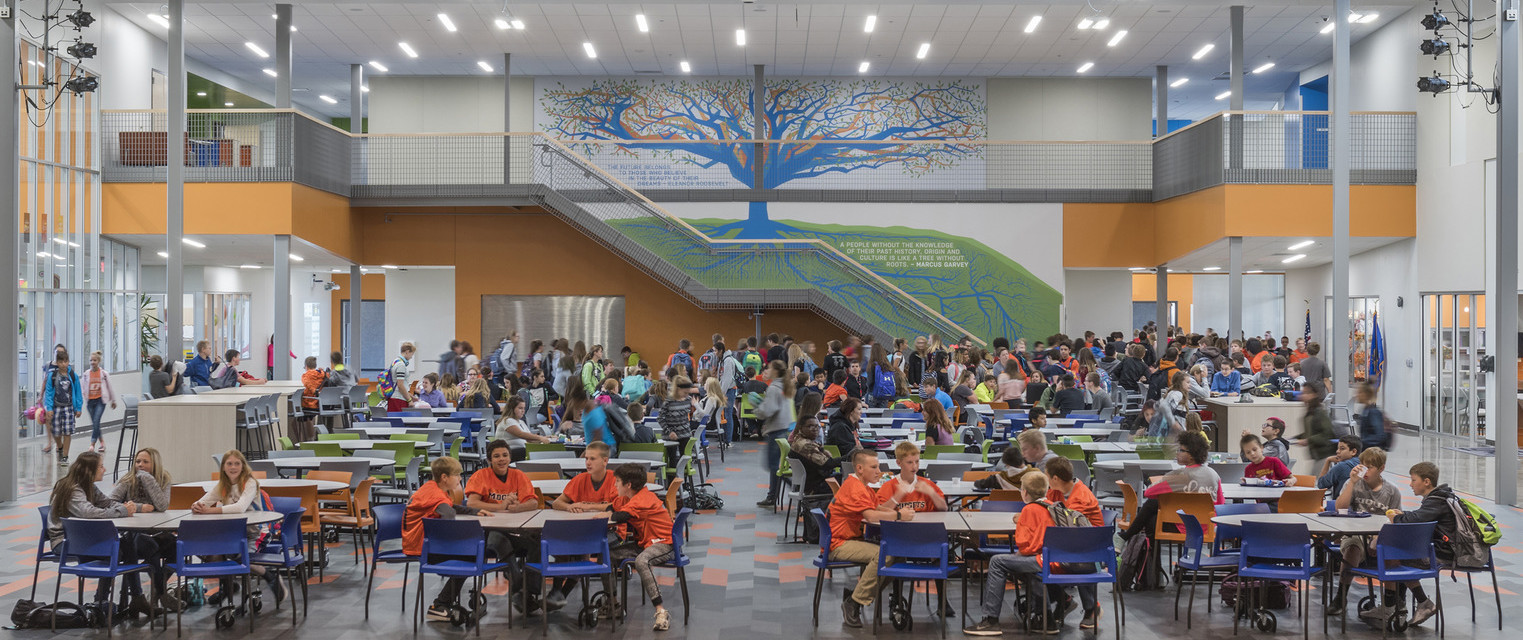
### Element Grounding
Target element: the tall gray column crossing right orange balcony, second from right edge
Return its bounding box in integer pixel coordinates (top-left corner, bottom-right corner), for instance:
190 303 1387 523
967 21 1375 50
1325 0 1352 402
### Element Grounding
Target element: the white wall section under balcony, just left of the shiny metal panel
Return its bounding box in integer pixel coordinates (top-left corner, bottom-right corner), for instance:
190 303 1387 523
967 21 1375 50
383 268 453 375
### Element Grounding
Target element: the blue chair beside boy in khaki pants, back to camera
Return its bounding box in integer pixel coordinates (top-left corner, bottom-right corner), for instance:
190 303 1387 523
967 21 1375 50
873 521 967 637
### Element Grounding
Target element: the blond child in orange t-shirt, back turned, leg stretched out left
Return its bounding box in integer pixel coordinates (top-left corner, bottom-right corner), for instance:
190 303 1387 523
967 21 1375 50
963 471 1060 635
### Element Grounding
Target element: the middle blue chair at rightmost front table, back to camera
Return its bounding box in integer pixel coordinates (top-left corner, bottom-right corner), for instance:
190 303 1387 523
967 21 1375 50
1232 523 1328 638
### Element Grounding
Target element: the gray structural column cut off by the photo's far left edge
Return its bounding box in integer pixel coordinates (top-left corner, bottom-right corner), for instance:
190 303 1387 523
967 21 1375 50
0 0 17 501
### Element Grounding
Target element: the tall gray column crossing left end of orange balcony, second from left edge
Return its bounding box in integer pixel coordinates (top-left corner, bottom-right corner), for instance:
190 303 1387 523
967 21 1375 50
163 0 186 360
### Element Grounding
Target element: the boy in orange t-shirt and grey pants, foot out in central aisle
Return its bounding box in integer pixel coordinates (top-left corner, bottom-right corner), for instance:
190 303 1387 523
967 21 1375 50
606 465 673 631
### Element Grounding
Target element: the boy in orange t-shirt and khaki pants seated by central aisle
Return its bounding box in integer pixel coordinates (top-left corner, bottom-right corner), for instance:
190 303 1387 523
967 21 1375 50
830 448 915 628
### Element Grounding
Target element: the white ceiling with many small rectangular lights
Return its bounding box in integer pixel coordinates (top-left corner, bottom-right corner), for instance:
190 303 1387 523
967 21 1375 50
102 0 1418 119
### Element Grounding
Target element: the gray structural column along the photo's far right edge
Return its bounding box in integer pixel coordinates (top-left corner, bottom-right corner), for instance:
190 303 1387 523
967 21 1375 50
1486 0 1523 504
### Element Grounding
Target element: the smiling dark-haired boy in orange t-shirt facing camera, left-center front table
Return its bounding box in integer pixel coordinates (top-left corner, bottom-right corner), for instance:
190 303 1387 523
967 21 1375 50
466 440 541 613
